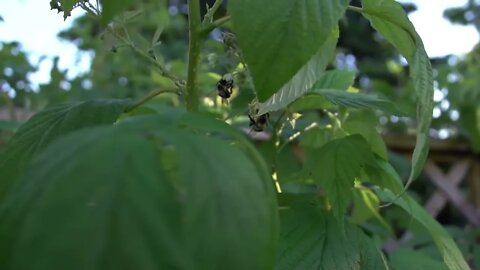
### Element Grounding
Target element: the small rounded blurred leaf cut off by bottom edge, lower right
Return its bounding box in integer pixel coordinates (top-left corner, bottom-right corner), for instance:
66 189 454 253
389 249 448 270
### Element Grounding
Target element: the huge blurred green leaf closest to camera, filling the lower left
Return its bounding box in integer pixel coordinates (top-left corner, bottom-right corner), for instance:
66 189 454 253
0 119 277 270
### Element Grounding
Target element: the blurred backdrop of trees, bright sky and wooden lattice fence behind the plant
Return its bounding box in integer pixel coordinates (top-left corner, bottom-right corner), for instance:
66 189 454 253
0 0 480 269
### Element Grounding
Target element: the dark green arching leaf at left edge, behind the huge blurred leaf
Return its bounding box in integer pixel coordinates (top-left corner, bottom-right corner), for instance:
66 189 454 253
0 99 128 201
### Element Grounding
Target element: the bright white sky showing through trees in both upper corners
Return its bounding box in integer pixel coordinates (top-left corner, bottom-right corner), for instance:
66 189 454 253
0 0 479 86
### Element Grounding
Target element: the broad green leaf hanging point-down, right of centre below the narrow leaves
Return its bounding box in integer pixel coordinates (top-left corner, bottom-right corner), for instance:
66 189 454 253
305 135 373 220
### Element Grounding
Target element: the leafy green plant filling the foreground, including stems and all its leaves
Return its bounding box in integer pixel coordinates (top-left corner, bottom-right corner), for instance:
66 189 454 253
0 0 468 269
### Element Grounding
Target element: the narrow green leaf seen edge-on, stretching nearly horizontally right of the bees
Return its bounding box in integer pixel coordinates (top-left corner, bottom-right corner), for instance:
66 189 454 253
312 89 406 116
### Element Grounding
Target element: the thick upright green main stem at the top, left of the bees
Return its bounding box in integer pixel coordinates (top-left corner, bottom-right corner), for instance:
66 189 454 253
186 0 202 111
